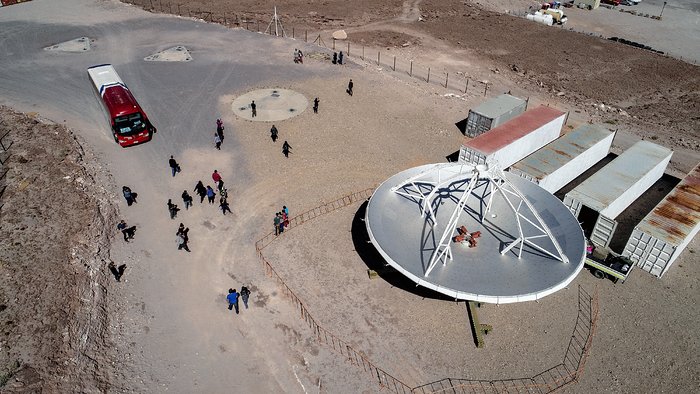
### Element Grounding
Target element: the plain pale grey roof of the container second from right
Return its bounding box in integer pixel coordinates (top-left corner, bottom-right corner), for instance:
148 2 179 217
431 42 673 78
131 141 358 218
566 141 673 212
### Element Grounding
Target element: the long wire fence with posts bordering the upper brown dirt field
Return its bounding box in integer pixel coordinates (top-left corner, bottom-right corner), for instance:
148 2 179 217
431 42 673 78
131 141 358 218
122 0 508 97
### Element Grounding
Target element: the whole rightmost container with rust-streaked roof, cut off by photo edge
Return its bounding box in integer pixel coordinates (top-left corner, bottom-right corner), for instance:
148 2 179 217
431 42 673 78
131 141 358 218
622 164 700 277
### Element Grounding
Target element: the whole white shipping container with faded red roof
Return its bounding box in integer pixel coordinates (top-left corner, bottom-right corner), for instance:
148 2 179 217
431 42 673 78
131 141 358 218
459 106 567 170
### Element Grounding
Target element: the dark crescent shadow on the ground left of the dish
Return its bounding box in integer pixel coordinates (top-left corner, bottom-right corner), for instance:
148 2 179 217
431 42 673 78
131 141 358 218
350 201 454 301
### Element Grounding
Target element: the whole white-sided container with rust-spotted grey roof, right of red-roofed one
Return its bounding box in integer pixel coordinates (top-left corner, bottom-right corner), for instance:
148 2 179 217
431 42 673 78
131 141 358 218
510 124 615 193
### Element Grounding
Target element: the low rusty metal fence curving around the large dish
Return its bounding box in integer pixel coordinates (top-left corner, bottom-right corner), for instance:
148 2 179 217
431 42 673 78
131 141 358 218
255 188 598 394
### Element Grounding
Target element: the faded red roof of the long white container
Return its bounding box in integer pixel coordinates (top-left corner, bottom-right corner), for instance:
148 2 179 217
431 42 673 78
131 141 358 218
464 106 564 155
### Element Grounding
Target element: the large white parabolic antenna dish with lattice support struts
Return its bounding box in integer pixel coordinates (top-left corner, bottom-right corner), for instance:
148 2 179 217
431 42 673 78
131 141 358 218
365 163 586 303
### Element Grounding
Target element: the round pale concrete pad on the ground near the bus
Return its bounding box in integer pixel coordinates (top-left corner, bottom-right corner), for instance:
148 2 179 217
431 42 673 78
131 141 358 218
231 89 309 122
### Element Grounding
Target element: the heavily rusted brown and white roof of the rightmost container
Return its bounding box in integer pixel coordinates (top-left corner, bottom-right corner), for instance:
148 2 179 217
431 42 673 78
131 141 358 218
637 164 700 245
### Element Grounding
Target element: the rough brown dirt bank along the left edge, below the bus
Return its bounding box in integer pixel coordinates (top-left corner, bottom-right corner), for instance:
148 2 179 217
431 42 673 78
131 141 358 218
0 107 114 392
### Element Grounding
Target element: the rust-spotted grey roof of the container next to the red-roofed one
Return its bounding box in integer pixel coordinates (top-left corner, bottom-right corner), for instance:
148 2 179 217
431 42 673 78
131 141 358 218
513 124 612 179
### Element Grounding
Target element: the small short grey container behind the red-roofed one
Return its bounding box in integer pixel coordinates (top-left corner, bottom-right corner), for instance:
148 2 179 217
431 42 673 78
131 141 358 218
464 94 527 137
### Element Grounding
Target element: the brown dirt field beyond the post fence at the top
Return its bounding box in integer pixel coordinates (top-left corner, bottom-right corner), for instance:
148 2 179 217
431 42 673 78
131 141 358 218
165 0 700 150
